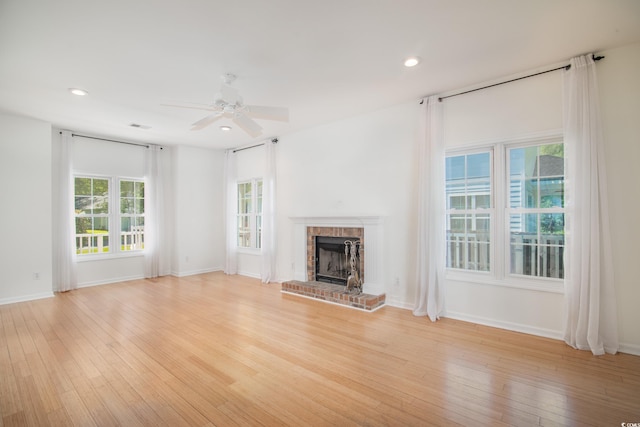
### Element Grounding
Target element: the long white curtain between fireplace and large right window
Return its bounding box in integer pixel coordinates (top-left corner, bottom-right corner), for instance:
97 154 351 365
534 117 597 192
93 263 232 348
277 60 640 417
413 96 445 322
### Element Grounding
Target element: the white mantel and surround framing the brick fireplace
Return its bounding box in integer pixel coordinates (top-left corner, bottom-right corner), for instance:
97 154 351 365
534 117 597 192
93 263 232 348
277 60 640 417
290 216 385 295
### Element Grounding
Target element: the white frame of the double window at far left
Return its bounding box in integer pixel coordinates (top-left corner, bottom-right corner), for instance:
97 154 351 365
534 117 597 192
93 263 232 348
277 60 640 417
73 172 147 262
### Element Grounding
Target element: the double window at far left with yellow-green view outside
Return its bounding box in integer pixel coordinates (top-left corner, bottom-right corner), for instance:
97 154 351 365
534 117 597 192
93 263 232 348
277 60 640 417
74 176 145 255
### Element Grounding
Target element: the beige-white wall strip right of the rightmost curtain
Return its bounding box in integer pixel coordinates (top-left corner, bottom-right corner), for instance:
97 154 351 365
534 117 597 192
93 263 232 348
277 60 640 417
598 43 640 354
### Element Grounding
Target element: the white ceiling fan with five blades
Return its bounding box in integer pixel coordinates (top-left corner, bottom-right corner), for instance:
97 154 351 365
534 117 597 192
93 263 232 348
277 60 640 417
163 74 289 137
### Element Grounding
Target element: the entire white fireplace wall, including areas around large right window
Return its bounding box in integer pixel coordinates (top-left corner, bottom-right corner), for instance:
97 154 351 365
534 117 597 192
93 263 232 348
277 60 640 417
258 44 640 354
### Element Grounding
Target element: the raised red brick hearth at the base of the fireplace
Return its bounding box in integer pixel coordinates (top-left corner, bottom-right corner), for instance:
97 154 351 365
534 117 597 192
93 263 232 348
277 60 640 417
282 280 386 311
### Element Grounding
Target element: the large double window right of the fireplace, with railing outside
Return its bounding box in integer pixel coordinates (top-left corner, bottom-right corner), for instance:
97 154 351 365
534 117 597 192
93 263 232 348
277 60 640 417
445 140 564 279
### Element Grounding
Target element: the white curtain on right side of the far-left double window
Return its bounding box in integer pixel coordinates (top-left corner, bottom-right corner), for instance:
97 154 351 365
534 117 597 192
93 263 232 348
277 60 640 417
144 145 169 278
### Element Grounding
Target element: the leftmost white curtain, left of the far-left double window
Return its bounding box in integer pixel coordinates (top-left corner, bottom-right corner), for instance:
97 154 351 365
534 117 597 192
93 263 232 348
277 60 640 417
53 131 78 292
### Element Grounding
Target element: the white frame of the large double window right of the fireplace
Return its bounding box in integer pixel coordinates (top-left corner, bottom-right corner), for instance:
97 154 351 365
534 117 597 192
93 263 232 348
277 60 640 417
444 132 568 293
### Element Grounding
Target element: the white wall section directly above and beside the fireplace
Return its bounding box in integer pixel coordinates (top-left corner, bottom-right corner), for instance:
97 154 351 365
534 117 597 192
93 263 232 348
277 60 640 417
277 101 418 306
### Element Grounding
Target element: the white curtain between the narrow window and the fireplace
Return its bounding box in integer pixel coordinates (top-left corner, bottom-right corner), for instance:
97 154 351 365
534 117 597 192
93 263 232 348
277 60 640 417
260 141 277 283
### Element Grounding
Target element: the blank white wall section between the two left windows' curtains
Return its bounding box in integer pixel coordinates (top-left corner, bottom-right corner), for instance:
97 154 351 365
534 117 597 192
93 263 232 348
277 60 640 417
172 146 225 276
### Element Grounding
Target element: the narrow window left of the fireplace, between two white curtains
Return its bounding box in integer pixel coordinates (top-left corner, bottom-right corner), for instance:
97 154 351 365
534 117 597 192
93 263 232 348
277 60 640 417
238 179 262 249
